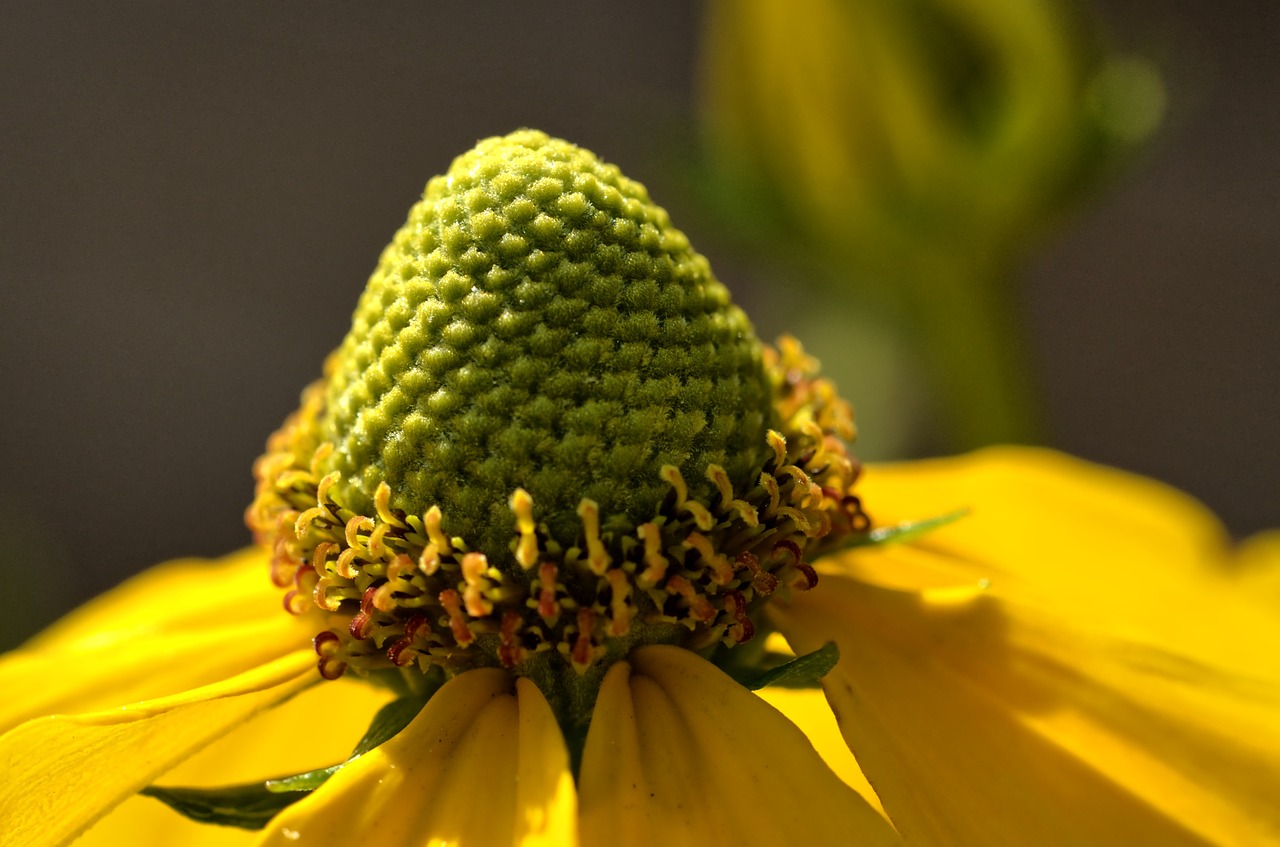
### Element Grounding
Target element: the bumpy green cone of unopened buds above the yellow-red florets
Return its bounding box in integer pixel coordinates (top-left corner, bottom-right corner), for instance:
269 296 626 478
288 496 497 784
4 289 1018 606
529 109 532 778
321 131 772 562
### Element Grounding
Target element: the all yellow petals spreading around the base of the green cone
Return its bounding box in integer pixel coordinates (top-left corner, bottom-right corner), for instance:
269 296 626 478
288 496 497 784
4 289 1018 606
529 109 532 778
0 448 1280 847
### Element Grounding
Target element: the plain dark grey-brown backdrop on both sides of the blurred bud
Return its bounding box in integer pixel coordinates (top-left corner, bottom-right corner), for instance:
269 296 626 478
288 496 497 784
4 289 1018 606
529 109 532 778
0 0 1280 644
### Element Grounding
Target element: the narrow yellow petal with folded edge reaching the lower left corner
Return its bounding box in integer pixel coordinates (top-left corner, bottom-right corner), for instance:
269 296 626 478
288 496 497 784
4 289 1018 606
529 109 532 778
0 651 316 847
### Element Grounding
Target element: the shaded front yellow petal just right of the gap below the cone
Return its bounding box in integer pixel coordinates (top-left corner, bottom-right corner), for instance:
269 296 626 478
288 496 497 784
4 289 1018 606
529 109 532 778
579 646 897 847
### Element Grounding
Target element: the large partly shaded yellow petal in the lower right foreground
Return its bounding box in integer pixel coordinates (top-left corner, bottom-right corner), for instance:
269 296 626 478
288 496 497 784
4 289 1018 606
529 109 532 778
771 560 1280 844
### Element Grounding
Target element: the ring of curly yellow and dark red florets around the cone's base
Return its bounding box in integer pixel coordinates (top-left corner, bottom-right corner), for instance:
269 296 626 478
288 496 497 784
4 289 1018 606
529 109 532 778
247 339 869 678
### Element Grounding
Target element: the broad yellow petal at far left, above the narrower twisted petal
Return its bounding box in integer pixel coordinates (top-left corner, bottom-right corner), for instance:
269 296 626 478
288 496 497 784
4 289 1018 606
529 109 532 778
0 551 314 732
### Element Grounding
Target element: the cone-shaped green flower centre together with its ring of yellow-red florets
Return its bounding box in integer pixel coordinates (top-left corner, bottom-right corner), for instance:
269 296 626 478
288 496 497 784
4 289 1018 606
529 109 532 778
247 132 868 696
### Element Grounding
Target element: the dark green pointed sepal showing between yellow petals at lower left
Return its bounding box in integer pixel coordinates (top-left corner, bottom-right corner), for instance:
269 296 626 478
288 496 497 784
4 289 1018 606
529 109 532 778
138 686 427 829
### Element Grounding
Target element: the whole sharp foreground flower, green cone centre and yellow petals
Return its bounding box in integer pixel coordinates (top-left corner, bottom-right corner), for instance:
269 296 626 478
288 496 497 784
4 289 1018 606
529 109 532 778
0 132 1280 847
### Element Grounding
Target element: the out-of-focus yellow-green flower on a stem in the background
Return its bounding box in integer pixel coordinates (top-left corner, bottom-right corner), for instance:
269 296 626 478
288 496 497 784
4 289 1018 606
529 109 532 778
700 0 1164 449
